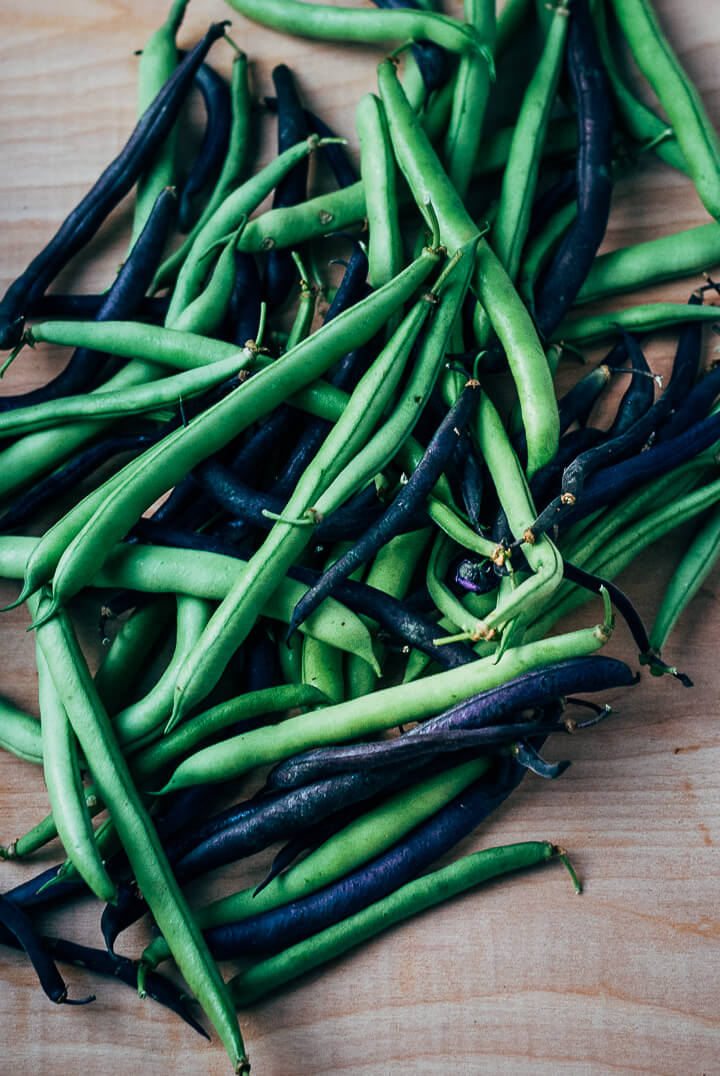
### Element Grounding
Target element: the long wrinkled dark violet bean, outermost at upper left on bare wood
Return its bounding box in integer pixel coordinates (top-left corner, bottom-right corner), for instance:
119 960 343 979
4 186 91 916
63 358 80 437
0 23 227 349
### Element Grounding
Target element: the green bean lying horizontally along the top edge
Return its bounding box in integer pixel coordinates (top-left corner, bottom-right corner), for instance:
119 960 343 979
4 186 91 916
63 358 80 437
222 0 482 53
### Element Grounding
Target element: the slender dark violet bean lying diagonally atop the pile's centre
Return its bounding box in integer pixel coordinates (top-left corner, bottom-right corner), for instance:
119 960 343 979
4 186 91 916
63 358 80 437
287 381 479 637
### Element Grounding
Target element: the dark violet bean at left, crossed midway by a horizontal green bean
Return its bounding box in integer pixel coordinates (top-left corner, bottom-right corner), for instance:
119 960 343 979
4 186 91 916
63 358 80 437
0 188 178 413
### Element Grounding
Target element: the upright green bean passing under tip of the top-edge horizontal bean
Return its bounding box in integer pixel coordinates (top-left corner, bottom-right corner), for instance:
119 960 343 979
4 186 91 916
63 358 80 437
442 0 495 198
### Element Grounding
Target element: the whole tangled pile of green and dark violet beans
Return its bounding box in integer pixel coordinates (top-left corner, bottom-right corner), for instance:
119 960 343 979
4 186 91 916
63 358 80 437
0 0 720 1073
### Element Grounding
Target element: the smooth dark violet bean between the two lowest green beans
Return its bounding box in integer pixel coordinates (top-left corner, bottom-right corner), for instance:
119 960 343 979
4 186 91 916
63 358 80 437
203 758 525 960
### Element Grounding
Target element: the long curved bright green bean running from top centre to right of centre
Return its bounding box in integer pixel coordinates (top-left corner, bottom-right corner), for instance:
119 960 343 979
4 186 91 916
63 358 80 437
378 60 560 476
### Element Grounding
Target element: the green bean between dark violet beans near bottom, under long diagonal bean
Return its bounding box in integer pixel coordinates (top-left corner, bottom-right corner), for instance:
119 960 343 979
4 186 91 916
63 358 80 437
142 758 490 967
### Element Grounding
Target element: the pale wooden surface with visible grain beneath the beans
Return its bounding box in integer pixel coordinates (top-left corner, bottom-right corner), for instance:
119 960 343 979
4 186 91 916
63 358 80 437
0 0 720 1076
